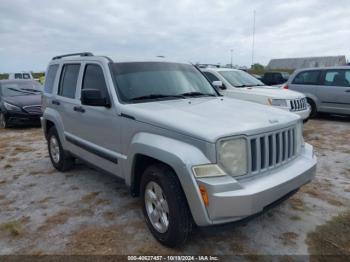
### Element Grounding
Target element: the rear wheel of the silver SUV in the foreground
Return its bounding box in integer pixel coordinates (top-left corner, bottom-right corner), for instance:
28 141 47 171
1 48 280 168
47 127 74 172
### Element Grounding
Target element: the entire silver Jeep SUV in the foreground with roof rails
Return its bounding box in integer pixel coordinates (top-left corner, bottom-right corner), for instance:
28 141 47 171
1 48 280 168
42 53 316 246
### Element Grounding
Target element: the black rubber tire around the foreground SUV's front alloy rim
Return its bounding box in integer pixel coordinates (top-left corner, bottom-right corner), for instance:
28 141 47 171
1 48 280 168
141 165 190 247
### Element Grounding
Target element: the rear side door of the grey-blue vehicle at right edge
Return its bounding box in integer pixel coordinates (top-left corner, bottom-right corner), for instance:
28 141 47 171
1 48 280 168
317 69 350 114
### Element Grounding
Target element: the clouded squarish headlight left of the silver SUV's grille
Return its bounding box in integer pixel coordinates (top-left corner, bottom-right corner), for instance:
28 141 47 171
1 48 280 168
217 138 248 176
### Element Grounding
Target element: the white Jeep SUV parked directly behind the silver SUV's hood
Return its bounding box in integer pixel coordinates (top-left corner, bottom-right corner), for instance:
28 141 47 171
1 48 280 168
201 68 311 121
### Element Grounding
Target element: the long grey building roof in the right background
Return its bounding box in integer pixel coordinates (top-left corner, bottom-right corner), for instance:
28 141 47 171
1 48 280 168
267 55 346 70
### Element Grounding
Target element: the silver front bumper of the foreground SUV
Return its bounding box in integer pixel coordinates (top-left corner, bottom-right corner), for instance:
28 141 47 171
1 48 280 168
197 144 317 225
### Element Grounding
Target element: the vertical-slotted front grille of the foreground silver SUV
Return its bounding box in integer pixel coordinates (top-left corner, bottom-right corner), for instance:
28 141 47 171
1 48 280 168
249 126 296 174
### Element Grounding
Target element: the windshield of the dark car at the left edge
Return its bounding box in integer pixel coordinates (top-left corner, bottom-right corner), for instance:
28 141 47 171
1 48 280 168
1 82 42 97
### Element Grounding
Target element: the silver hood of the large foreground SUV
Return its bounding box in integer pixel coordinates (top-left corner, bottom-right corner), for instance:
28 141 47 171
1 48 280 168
123 97 299 142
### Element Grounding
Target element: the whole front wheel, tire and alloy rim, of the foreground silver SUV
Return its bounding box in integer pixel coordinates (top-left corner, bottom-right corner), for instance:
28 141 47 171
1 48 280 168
141 164 193 247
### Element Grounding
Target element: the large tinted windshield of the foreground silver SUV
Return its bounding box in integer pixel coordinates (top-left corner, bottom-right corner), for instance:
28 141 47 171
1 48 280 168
112 62 217 102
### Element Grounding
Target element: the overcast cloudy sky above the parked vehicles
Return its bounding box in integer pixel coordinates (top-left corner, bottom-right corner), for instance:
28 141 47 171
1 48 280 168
0 0 350 72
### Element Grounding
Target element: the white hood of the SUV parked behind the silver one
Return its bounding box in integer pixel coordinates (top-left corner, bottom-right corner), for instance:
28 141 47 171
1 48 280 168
225 86 305 99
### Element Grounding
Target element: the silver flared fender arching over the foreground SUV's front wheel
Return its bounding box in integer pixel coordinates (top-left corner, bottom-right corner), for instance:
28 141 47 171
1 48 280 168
125 133 212 225
